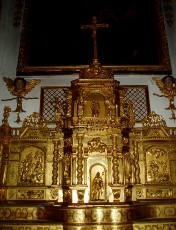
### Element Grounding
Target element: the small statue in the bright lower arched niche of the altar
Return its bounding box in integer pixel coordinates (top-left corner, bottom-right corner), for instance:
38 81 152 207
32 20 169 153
92 172 103 200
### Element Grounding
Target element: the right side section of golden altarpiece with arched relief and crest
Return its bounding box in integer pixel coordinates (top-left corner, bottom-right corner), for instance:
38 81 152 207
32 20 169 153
133 112 176 200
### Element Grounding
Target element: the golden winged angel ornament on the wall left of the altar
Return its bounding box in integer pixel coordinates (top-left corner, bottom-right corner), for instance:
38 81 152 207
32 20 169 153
2 77 40 123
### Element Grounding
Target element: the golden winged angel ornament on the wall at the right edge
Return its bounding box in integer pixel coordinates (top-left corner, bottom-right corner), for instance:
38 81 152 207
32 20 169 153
153 75 176 120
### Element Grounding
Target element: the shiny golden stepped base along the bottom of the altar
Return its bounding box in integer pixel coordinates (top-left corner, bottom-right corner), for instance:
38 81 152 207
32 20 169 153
0 200 176 230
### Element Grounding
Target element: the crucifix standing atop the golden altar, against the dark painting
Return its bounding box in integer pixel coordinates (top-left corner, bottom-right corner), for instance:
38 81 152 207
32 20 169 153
81 16 109 60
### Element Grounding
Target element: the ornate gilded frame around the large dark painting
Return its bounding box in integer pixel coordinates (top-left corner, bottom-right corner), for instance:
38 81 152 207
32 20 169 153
17 0 171 76
